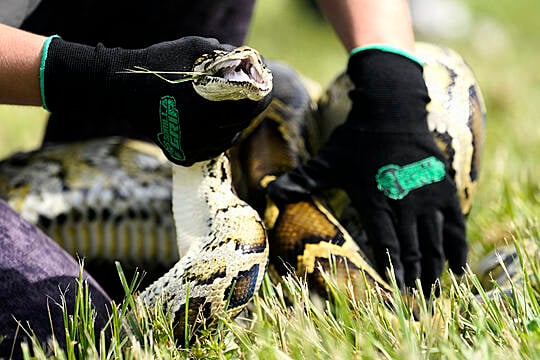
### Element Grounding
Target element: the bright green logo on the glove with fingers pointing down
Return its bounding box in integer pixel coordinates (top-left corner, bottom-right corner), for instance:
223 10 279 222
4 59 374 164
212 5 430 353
375 156 445 200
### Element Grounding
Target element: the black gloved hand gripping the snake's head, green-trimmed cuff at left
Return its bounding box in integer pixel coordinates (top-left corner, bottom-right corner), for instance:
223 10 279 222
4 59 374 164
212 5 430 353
41 37 270 166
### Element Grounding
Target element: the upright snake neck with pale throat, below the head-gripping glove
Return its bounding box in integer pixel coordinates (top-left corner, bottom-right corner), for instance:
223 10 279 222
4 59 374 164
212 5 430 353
140 154 268 337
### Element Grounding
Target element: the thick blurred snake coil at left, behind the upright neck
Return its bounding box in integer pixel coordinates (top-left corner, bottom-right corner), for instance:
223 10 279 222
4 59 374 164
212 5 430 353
0 138 178 267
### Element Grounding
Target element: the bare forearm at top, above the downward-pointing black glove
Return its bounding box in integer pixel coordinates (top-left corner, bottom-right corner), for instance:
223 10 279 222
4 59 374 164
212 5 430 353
318 0 414 53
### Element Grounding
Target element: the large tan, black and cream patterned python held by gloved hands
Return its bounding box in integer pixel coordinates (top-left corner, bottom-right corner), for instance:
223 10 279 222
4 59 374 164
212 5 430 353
0 44 485 334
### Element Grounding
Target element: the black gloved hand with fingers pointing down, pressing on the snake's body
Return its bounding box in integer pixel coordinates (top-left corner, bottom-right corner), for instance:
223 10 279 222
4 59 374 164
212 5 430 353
267 49 467 294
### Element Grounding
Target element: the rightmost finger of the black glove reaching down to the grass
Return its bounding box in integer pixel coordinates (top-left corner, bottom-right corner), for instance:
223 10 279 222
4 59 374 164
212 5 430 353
443 198 468 275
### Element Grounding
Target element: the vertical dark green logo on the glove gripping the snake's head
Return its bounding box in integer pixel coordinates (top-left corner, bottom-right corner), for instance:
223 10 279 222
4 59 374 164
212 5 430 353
157 96 186 161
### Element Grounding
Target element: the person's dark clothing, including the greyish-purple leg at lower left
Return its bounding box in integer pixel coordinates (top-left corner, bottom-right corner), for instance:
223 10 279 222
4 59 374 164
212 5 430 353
0 0 254 358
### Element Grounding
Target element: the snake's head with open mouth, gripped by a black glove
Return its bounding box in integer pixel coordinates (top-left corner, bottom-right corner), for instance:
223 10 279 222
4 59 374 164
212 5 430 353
193 46 272 101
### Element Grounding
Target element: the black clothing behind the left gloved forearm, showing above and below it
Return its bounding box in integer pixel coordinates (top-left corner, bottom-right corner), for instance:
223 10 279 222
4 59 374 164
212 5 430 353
21 0 255 142
